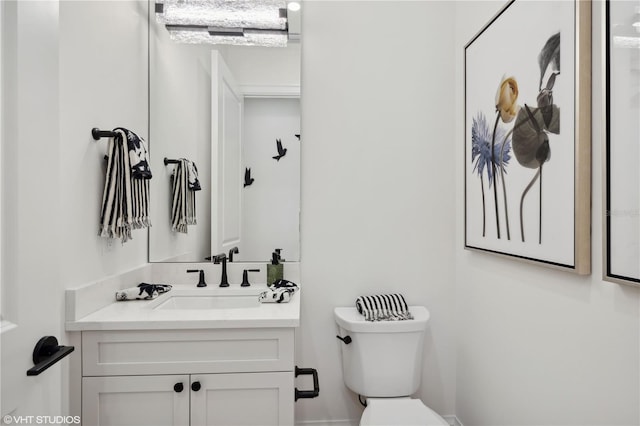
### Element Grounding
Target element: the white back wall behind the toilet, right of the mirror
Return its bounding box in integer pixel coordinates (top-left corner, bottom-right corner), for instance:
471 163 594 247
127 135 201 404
296 1 459 424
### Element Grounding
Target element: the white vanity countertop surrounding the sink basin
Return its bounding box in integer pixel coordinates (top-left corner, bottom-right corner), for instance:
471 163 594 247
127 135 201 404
66 285 301 331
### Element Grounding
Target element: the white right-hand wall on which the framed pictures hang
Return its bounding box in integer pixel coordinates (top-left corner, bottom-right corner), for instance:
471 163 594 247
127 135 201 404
453 1 640 426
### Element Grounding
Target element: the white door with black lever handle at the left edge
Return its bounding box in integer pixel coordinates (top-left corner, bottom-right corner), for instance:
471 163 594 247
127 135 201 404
0 1 69 423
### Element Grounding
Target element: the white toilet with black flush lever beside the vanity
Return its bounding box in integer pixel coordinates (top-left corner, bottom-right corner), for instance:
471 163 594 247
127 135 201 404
334 306 449 426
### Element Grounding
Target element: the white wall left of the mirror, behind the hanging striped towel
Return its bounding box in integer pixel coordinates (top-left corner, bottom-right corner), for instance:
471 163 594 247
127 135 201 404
59 1 149 288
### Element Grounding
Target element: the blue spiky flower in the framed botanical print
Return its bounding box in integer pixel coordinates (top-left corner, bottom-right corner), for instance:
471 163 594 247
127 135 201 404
471 112 511 187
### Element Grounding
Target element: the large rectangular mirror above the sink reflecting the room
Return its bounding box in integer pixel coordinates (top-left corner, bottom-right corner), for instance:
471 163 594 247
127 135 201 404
148 2 301 262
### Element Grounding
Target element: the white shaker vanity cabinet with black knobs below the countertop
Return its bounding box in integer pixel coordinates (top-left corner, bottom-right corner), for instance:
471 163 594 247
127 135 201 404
81 328 294 426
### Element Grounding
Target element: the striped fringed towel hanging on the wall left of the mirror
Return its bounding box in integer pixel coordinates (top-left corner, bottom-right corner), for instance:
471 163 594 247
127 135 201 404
98 128 151 243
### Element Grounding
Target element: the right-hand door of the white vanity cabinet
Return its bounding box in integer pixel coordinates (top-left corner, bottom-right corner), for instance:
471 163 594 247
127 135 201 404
191 372 294 426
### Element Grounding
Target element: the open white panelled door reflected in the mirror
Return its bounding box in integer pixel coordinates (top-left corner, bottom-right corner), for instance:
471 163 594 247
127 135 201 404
211 50 244 255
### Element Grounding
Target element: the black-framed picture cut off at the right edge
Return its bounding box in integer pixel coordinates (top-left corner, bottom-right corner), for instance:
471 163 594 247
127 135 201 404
603 1 640 286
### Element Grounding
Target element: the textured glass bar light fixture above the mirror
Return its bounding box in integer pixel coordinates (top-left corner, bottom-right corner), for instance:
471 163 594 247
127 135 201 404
155 0 300 47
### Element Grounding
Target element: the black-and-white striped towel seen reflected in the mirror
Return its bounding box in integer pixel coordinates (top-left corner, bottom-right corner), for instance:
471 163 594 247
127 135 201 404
171 158 200 234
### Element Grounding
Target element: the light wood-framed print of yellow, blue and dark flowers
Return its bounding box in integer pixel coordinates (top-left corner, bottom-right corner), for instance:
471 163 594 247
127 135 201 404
464 0 591 274
